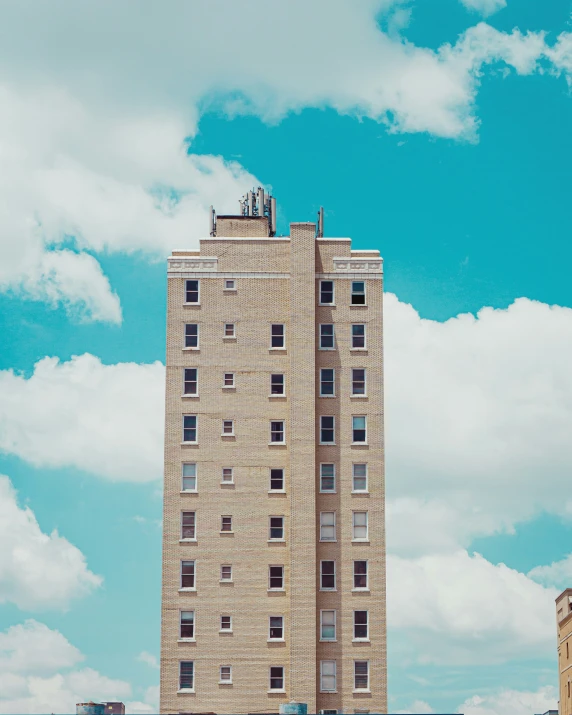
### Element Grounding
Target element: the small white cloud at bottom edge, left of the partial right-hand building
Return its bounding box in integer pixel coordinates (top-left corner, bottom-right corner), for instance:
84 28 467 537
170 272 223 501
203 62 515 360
457 685 558 715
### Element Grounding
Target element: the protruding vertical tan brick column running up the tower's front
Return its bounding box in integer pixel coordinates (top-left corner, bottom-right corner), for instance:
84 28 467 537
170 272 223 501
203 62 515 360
288 223 316 713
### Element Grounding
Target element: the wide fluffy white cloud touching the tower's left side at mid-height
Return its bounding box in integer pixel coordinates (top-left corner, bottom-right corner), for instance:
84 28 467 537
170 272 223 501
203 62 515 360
0 354 165 482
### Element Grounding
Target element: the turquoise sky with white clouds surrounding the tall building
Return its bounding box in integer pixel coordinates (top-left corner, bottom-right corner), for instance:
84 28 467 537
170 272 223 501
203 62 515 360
0 0 572 715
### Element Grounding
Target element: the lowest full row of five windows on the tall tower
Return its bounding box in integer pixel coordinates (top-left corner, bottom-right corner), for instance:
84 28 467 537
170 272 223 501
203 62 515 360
179 660 369 692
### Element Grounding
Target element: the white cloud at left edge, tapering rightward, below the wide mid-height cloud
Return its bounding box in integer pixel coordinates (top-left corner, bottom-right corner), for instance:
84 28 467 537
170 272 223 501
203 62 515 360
0 476 102 608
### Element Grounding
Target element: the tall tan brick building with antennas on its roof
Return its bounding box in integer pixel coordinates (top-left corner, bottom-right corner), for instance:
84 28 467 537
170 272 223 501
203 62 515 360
160 190 387 713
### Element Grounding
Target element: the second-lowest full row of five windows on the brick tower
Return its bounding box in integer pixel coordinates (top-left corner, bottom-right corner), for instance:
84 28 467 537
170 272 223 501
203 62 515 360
179 609 369 642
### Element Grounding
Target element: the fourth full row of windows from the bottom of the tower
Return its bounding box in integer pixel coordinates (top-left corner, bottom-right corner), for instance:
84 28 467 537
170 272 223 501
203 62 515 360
177 511 368 541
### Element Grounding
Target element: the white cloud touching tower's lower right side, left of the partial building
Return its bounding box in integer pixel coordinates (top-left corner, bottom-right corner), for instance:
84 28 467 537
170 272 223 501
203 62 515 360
387 551 558 665
